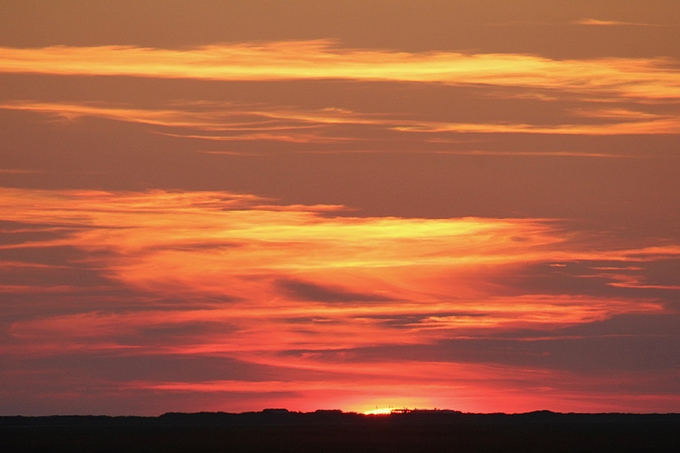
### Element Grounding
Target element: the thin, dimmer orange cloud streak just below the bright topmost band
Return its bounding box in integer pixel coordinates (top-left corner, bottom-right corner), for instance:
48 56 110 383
5 101 680 147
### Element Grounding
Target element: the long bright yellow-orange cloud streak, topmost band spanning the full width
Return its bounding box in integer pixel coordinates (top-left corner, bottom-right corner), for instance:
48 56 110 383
0 41 680 99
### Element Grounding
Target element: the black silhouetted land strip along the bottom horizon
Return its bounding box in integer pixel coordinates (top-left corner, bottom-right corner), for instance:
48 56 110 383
0 409 680 453
